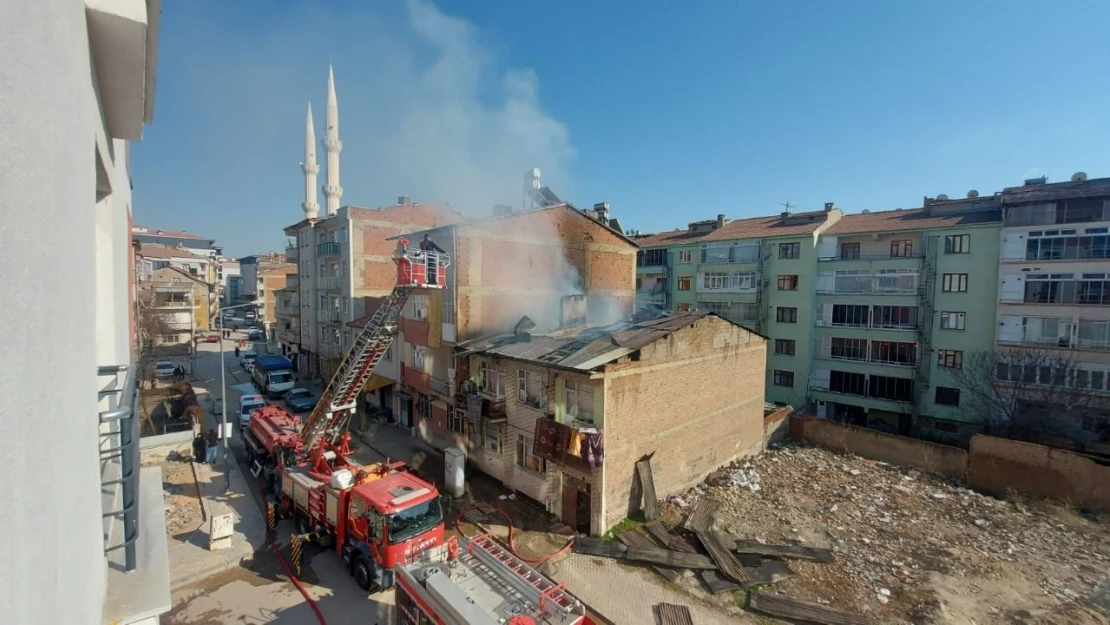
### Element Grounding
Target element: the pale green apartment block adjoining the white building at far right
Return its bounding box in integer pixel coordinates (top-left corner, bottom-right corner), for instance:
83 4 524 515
812 193 1000 438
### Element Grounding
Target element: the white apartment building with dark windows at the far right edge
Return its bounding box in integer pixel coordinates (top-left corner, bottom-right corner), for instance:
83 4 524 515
996 172 1110 453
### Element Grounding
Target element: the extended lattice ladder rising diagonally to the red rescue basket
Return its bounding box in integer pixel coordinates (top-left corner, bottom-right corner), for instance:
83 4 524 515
301 250 447 451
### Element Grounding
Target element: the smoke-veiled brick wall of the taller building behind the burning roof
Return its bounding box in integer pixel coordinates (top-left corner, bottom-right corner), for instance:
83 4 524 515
454 206 636 341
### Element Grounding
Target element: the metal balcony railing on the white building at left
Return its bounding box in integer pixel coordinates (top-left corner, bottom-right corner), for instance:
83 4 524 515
97 365 140 571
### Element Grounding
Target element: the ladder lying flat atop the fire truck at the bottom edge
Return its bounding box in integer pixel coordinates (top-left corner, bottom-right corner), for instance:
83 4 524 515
466 534 585 617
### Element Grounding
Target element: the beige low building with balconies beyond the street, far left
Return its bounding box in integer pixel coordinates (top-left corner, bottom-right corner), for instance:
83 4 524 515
137 266 213 346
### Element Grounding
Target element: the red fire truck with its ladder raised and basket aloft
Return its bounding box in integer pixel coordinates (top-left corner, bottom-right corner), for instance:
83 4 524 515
243 240 450 591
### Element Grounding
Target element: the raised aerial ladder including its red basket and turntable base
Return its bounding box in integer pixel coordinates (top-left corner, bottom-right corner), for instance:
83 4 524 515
300 239 451 474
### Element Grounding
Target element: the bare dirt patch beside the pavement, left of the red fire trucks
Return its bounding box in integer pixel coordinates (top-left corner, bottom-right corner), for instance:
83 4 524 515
142 443 204 547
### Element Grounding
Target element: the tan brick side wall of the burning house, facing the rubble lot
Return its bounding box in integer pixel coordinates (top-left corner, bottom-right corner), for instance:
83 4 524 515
604 316 767 527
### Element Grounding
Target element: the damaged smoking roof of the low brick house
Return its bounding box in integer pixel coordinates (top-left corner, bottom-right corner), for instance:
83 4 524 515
456 312 766 371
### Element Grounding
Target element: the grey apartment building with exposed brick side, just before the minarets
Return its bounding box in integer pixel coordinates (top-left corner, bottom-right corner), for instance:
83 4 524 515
286 196 462 377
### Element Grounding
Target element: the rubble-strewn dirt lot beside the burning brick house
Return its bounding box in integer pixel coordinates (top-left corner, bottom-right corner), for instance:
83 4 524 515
665 446 1110 625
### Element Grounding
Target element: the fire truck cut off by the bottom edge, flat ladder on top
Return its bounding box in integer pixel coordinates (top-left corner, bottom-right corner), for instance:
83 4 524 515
393 534 595 625
